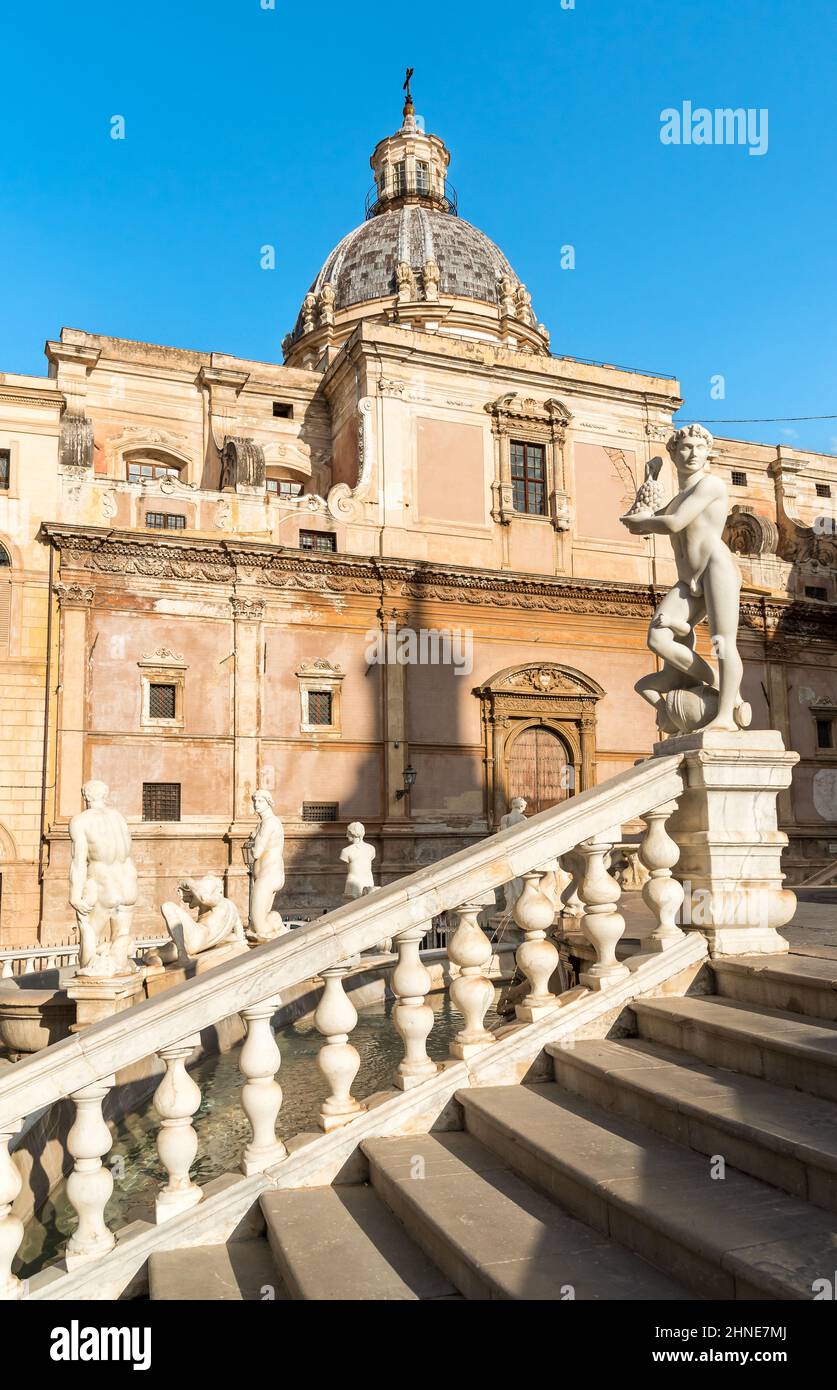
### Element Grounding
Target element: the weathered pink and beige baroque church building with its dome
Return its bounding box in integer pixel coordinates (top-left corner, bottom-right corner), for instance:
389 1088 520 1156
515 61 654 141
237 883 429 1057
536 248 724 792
0 99 837 944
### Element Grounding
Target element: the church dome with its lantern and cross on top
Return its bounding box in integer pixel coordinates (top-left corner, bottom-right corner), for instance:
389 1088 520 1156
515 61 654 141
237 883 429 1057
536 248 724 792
282 75 549 367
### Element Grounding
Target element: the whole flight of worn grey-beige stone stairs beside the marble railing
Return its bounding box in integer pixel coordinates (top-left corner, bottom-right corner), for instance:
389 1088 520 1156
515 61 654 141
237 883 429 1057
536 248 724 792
149 956 837 1300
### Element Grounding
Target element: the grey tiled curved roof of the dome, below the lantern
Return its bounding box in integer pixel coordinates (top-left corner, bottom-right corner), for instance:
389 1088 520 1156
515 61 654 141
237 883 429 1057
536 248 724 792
293 203 520 338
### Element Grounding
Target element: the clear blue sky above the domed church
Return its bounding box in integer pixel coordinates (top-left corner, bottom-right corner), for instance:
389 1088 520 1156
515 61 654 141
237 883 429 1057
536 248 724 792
0 0 837 452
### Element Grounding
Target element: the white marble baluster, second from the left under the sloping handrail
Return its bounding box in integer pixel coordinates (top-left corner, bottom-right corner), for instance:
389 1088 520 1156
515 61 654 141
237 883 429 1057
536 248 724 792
64 1076 117 1269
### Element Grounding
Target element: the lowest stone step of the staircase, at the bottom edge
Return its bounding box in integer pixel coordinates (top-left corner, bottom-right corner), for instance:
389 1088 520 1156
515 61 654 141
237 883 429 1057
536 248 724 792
149 1240 280 1302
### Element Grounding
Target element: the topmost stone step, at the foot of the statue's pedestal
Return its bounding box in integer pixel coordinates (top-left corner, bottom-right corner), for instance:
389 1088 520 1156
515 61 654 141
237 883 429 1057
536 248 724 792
712 952 837 1022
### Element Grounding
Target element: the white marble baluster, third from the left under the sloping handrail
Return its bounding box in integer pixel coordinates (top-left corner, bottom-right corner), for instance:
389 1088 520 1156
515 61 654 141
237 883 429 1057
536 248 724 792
154 1034 203 1225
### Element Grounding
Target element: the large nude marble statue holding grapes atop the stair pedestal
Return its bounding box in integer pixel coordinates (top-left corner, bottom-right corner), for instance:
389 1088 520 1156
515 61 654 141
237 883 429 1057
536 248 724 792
621 424 752 734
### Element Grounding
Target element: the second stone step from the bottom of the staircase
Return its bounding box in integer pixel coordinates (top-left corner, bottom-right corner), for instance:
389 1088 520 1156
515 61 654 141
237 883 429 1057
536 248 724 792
261 1184 456 1301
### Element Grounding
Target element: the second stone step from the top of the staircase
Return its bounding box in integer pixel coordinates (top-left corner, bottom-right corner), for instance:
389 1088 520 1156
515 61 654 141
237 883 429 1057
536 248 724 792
631 995 837 1101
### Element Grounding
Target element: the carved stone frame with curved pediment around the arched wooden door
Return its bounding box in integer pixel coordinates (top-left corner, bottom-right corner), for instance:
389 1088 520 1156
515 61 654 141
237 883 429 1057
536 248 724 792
474 662 605 830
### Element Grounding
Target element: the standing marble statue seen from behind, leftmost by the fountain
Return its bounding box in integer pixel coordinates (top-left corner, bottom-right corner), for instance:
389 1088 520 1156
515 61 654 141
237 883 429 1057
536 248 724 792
70 781 138 980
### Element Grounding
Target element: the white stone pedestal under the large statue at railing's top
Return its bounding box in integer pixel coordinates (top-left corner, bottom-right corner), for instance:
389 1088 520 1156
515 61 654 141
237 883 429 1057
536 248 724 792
653 728 799 956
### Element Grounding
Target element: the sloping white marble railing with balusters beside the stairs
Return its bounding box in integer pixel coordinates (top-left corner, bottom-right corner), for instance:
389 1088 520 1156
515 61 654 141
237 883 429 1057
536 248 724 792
0 755 684 1298
